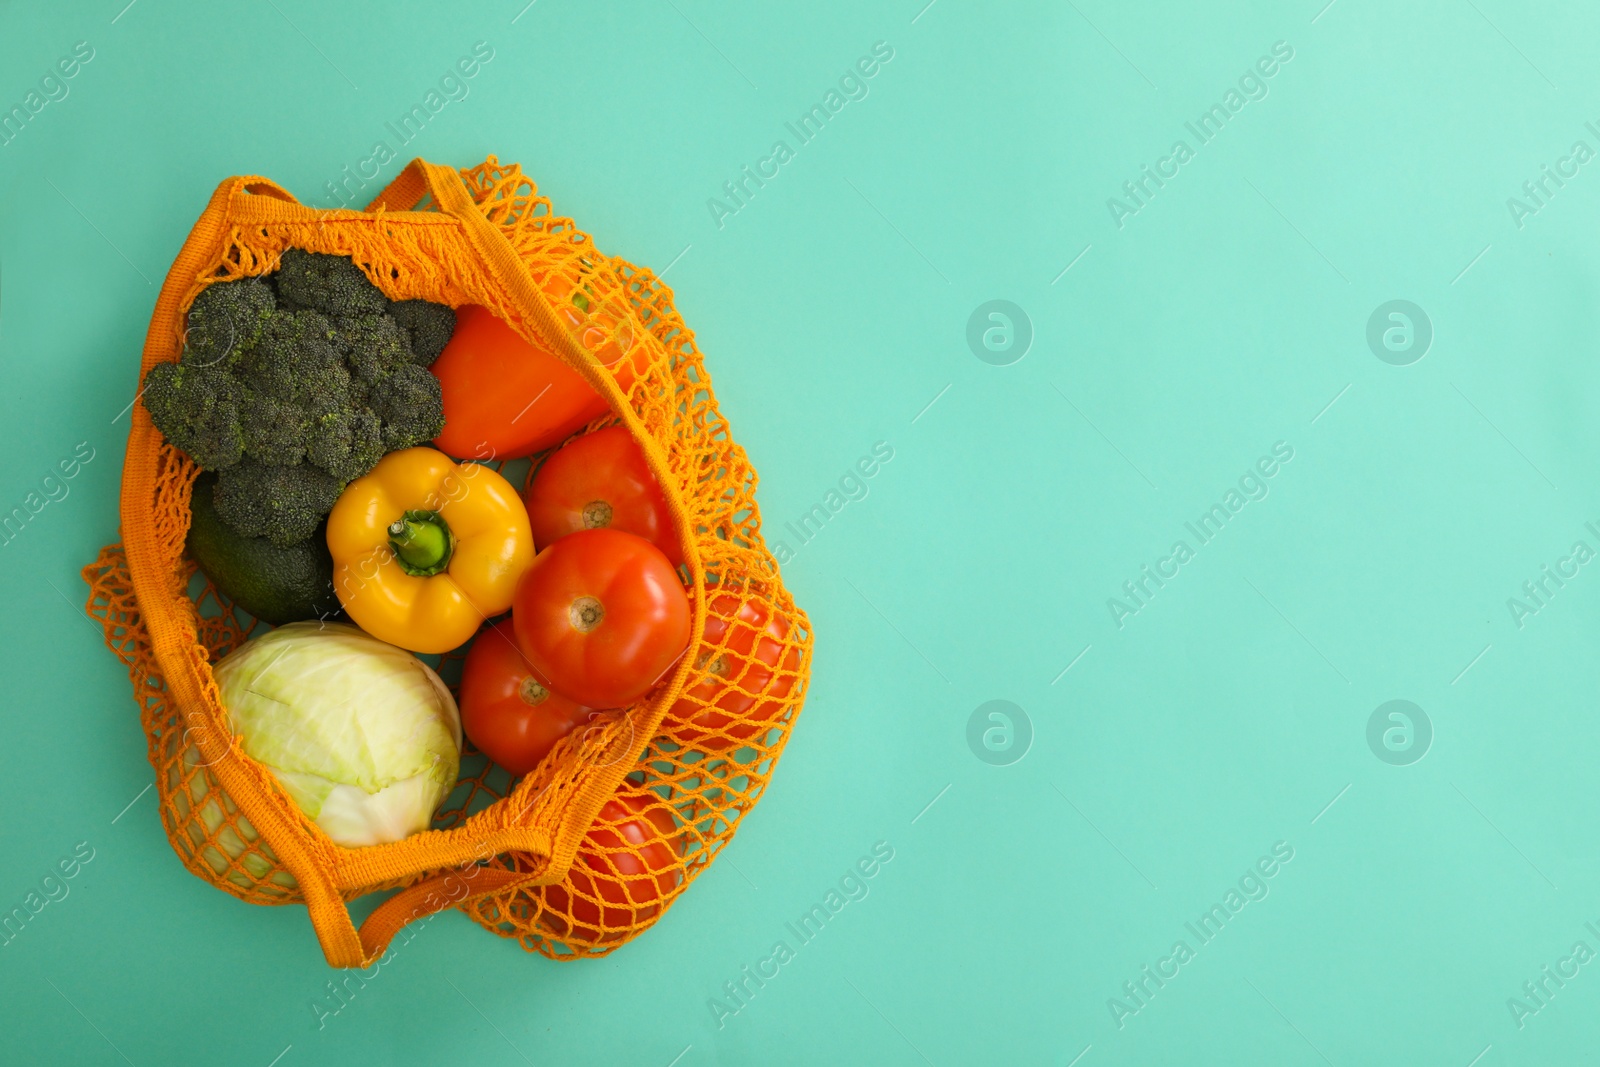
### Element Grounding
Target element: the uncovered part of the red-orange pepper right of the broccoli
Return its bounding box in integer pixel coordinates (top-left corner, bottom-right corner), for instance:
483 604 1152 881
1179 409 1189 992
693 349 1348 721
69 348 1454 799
430 304 606 459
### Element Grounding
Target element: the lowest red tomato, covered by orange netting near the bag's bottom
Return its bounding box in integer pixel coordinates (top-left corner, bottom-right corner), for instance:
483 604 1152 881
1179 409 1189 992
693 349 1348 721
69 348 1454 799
534 785 685 944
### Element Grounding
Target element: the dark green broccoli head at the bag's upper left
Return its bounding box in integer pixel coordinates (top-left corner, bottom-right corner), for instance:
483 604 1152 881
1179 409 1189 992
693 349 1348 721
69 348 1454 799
144 248 456 545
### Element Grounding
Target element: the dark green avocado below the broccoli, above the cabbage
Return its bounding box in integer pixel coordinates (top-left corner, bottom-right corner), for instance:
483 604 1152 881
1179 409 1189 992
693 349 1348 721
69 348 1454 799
189 472 339 625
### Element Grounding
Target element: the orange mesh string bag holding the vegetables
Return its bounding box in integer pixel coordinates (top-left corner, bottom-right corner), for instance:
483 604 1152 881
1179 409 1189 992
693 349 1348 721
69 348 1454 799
83 157 811 966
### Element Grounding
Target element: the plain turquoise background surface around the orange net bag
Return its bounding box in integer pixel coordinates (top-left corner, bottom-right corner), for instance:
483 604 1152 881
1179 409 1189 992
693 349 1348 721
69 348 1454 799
0 0 1600 1067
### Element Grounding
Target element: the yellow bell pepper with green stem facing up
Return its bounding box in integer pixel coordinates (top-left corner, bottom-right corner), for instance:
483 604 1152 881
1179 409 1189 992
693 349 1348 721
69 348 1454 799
328 448 533 653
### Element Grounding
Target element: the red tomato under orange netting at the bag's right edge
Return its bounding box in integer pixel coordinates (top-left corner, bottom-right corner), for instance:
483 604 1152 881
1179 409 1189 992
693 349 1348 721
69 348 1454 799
662 593 800 752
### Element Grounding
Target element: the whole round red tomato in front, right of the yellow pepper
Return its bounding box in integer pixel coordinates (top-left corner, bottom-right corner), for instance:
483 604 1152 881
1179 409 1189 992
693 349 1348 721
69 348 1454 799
510 528 693 707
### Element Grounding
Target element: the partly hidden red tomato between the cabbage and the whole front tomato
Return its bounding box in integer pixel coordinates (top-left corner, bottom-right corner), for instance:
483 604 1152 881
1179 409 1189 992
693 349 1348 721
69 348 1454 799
459 619 595 776
